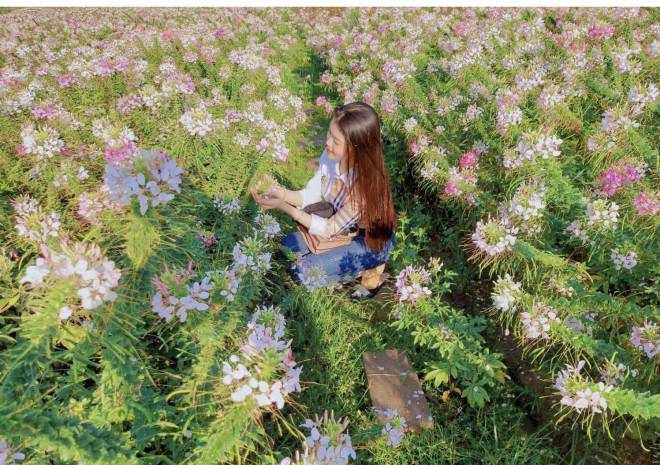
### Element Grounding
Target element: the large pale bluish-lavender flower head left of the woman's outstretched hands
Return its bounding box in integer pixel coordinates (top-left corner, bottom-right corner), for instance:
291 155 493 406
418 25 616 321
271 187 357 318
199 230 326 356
103 150 183 215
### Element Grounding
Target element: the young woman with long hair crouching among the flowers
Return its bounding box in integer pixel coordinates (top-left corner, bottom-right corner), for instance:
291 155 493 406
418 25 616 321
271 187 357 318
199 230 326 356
252 102 397 297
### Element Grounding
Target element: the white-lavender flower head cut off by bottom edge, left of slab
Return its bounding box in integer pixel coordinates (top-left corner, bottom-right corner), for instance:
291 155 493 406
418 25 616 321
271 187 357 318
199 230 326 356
279 410 357 465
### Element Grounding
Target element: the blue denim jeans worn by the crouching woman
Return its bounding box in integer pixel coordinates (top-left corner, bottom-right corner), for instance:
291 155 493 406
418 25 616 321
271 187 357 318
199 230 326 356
282 231 396 285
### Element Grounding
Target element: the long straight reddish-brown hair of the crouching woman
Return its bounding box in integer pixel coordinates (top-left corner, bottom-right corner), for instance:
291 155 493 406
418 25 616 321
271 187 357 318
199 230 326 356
332 102 396 252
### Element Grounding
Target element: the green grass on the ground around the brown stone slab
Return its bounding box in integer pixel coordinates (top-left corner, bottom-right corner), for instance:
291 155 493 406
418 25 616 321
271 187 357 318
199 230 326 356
256 276 566 465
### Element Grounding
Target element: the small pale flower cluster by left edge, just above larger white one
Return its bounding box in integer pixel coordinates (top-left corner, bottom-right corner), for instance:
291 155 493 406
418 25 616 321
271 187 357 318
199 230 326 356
11 195 61 244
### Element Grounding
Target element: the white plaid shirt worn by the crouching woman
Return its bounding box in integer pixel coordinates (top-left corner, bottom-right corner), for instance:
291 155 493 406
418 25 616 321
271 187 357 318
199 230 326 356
299 150 360 238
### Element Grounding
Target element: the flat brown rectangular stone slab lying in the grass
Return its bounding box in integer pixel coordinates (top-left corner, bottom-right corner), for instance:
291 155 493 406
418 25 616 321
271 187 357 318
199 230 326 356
362 349 433 431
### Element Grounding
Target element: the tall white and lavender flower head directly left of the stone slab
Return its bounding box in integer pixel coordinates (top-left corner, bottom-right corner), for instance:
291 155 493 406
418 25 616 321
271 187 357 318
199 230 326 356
222 306 302 409
